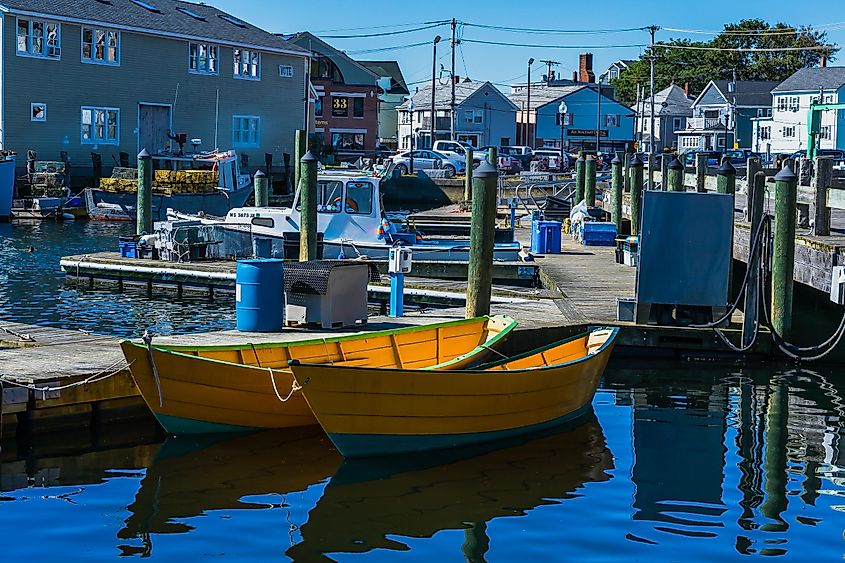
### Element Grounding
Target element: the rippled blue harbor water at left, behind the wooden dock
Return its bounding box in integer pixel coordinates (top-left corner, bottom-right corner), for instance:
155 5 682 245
0 221 235 337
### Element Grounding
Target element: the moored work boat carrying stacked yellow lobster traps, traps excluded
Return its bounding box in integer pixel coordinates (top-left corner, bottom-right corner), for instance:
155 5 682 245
84 151 252 221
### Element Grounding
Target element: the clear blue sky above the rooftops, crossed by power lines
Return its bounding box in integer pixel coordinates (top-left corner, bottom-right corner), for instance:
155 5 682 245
201 0 845 91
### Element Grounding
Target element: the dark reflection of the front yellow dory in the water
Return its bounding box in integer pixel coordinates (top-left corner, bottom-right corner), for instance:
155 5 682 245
287 420 613 561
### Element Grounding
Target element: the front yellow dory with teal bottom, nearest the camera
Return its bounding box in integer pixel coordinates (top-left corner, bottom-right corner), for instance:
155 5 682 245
290 328 618 458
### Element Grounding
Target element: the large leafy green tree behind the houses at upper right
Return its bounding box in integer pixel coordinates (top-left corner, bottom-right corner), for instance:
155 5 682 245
612 19 839 106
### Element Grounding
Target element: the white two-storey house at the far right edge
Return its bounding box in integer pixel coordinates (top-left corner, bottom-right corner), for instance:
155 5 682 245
752 67 845 154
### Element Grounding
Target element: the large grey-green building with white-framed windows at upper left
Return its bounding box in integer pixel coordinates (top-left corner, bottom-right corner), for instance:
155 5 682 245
0 0 310 175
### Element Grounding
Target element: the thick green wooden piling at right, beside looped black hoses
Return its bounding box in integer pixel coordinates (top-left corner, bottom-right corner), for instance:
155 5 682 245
772 166 798 338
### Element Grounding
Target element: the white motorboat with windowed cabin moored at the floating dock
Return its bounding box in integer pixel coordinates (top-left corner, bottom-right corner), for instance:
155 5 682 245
170 171 523 261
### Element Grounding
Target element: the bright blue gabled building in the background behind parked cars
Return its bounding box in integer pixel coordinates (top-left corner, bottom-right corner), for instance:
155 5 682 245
510 83 635 152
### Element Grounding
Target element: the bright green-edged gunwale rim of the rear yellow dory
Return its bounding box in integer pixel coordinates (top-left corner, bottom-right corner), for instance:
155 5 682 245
119 315 519 372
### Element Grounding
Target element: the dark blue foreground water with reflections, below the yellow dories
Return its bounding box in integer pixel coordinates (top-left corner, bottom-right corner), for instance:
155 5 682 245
0 362 845 562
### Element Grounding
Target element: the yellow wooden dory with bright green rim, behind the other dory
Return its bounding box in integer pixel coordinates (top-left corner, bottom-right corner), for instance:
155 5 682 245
121 316 516 434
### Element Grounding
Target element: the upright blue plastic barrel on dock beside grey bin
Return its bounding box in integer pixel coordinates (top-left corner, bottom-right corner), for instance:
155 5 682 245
235 259 285 332
